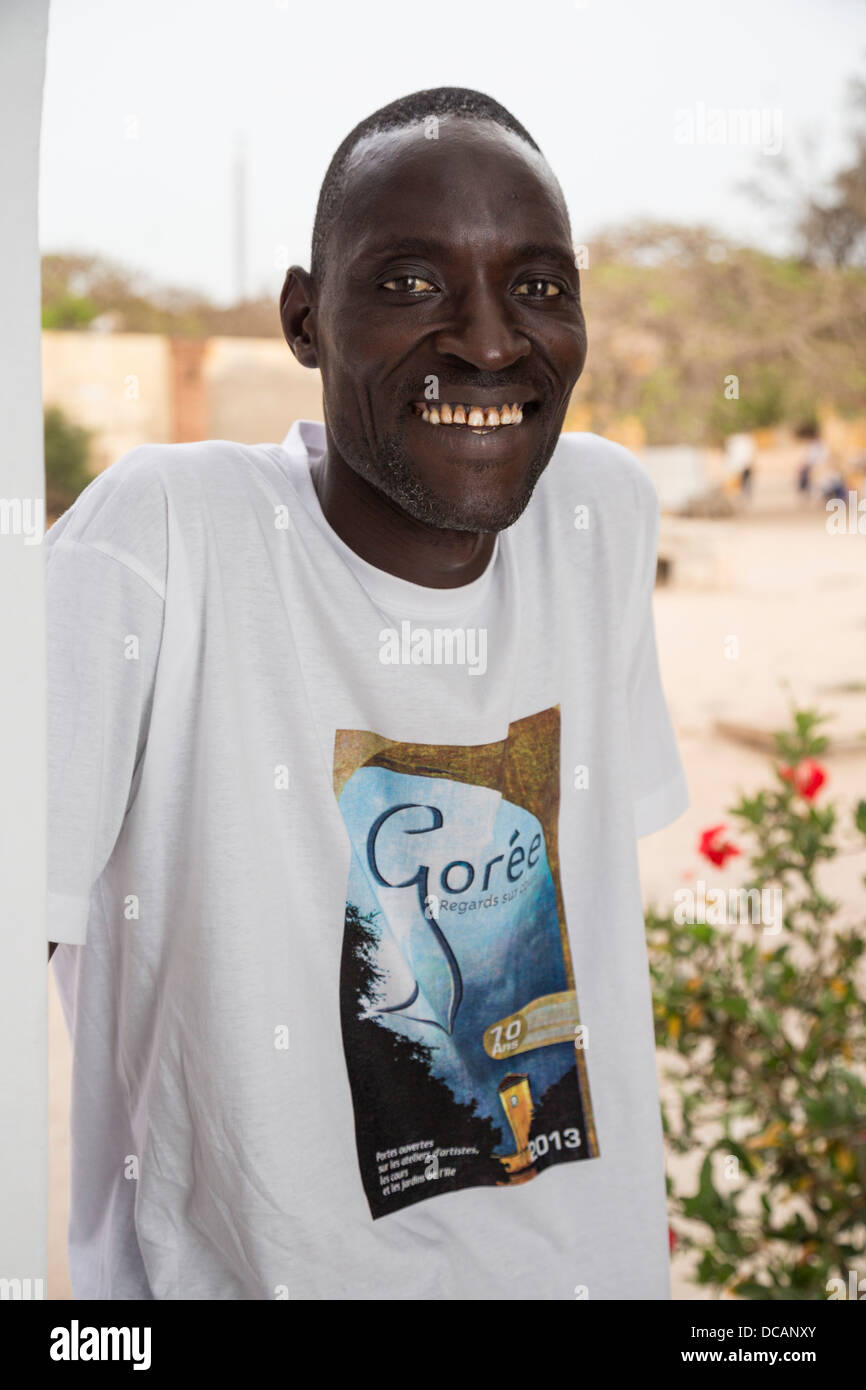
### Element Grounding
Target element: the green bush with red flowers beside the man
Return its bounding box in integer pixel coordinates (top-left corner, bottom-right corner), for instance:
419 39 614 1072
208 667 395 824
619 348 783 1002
646 710 866 1300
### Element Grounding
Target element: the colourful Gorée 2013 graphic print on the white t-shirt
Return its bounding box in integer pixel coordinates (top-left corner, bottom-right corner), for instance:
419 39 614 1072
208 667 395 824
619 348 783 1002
334 706 599 1219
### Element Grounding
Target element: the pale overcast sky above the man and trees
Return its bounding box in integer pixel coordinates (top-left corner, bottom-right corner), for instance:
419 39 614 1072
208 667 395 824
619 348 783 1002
40 0 866 303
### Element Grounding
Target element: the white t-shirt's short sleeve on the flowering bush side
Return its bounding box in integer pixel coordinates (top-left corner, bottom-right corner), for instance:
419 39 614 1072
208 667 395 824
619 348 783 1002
626 466 688 837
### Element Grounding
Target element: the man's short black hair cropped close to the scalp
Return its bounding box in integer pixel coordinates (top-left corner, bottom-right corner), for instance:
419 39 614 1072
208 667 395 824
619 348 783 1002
310 88 542 279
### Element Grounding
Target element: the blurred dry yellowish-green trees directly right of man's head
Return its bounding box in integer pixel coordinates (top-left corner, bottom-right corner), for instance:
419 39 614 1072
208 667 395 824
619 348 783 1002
575 222 866 445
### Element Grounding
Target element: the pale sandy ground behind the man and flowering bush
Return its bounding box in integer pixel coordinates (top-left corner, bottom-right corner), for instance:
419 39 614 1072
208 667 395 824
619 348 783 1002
49 475 866 1300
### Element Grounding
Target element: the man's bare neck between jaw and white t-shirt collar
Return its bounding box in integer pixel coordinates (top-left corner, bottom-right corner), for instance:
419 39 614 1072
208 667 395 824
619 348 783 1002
311 452 496 589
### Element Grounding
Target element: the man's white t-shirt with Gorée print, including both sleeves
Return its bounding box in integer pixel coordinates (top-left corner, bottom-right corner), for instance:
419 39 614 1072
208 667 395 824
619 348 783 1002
46 421 688 1300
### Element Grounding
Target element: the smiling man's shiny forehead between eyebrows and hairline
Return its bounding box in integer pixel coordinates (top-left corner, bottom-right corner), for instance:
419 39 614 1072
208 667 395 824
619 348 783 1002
338 118 569 252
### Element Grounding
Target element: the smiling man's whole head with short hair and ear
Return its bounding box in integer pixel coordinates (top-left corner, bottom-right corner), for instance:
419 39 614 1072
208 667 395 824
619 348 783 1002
281 88 587 531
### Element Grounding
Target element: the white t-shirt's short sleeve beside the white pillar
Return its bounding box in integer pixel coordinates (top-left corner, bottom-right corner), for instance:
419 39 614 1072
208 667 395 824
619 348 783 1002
44 464 164 945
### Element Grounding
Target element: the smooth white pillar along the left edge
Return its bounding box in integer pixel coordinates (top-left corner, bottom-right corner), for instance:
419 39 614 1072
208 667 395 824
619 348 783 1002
0 0 49 1297
